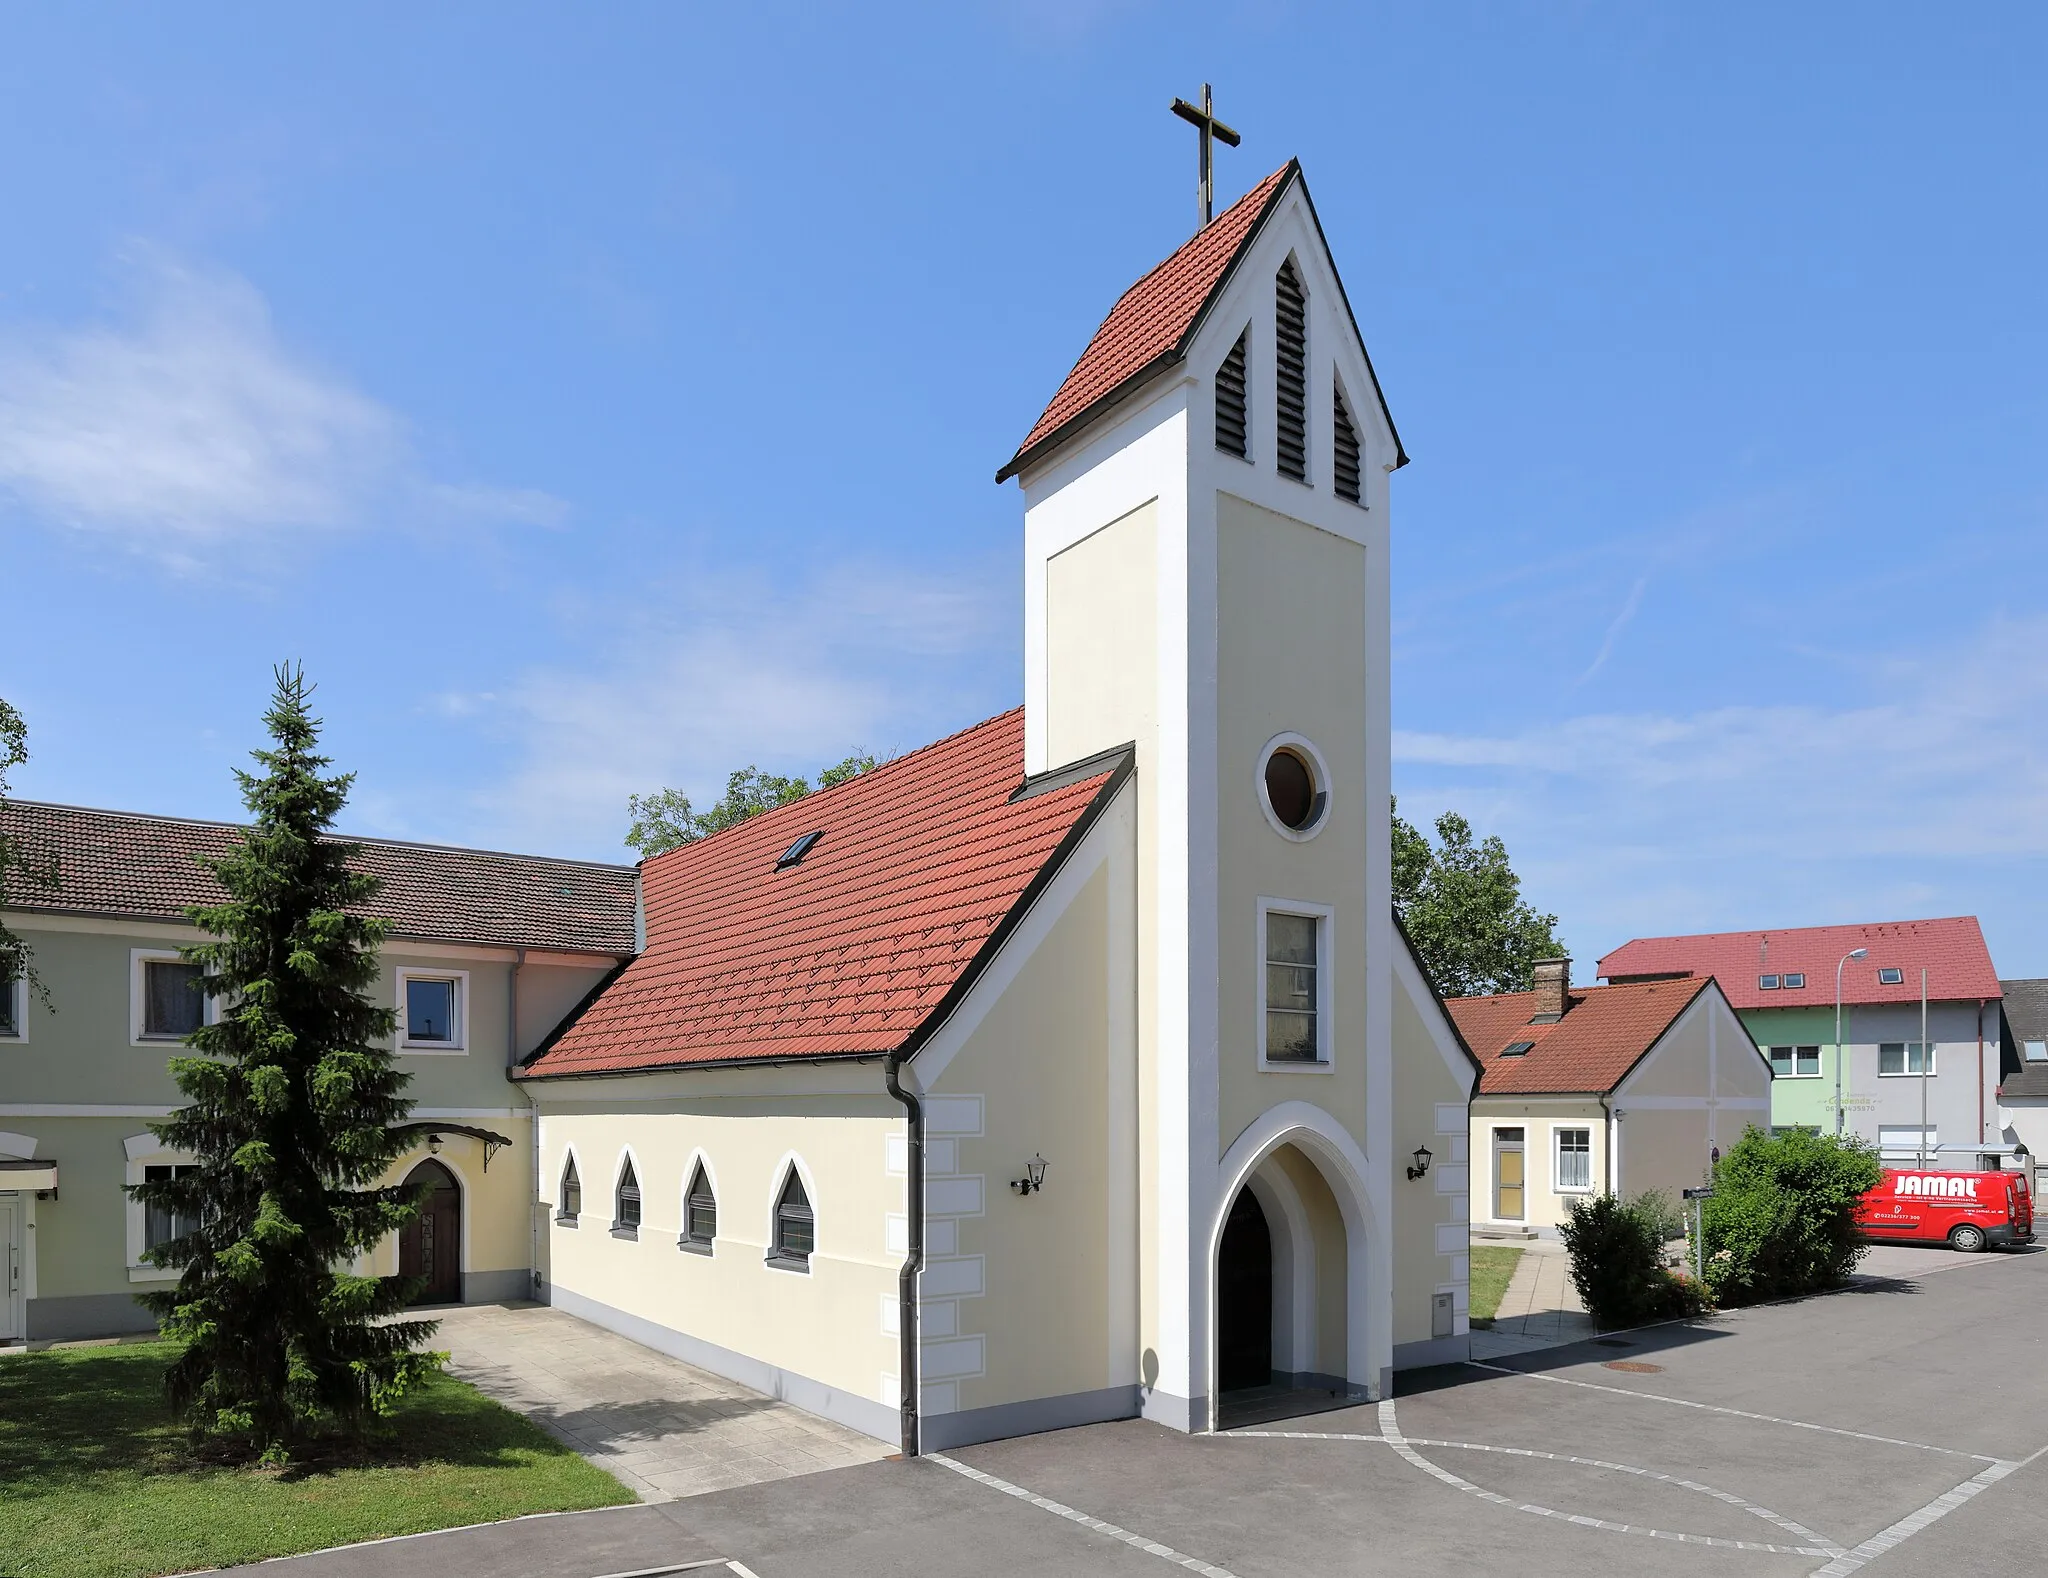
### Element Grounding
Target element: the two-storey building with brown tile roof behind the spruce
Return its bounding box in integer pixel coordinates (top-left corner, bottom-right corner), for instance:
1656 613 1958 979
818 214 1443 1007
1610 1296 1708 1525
0 800 635 1341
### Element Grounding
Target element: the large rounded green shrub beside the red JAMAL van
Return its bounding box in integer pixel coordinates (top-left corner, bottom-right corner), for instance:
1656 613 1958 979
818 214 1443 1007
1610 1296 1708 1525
1700 1128 1884 1304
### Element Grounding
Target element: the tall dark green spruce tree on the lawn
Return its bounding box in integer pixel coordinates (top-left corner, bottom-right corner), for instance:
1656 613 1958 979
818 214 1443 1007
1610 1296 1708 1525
133 665 440 1459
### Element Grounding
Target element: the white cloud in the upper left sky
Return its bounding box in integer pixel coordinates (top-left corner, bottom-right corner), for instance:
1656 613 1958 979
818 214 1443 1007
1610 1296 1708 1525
0 246 561 561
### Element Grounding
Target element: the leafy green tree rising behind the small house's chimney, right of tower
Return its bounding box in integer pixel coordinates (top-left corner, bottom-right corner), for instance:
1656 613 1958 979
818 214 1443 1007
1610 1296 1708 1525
1393 806 1565 997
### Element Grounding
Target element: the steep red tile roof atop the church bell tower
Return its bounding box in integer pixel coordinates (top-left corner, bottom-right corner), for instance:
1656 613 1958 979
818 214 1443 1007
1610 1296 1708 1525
995 160 1407 483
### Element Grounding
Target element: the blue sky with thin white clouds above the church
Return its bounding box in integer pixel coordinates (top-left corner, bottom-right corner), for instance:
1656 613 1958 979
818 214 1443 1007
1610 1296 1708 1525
0 0 2048 974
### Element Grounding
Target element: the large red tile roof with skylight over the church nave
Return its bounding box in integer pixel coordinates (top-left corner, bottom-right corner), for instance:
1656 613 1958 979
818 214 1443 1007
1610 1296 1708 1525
522 708 1128 1079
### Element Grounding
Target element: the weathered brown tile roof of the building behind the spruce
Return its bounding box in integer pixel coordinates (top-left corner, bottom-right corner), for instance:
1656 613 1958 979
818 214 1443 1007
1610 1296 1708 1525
0 800 633 958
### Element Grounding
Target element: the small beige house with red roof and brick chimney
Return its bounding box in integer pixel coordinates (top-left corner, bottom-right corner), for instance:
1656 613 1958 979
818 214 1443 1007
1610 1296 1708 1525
1450 960 1772 1238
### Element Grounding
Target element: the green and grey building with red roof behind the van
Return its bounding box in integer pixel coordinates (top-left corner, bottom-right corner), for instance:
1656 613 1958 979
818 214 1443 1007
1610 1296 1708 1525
1599 915 2005 1167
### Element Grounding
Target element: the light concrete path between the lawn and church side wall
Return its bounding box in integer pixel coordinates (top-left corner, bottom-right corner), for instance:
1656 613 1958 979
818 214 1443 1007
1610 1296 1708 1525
434 1304 891 1502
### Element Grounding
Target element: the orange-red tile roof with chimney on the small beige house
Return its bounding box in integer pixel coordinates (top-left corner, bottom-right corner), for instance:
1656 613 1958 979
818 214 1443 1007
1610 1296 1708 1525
1446 980 1708 1095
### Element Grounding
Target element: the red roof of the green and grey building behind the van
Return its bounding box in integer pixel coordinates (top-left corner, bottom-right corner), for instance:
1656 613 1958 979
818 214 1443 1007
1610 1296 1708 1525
1599 915 1999 1009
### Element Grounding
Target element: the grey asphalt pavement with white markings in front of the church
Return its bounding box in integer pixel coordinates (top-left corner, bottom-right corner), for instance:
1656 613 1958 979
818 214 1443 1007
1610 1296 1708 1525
270 1251 2048 1578
